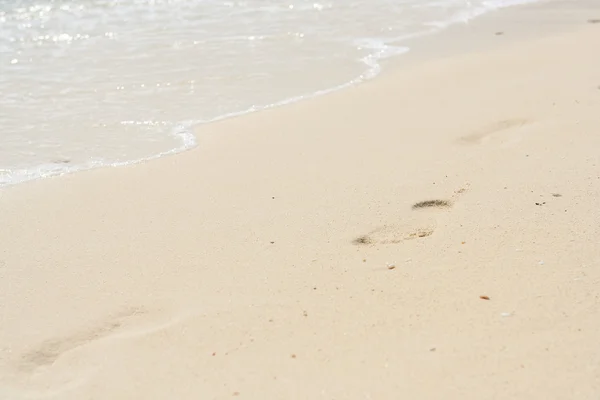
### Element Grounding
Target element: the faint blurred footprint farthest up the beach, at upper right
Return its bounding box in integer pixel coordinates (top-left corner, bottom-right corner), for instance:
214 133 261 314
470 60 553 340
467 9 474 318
458 118 531 147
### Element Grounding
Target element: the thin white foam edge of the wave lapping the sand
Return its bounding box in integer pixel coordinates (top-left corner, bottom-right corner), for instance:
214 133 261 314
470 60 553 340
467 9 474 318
0 0 564 190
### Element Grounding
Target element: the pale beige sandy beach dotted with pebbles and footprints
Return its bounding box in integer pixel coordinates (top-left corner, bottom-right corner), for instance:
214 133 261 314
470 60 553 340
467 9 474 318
0 0 600 400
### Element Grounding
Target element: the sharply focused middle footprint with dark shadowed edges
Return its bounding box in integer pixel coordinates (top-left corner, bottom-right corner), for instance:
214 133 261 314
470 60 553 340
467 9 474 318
352 185 468 246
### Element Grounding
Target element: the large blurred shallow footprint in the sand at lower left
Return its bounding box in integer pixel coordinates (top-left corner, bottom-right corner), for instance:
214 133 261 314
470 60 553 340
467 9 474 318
0 307 192 398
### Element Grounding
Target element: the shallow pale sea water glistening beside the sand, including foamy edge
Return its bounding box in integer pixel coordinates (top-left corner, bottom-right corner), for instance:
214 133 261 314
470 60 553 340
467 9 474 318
0 0 540 186
